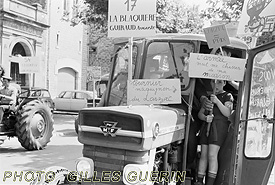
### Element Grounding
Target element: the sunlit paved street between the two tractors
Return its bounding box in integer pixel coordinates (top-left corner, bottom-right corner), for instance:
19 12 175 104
0 113 82 185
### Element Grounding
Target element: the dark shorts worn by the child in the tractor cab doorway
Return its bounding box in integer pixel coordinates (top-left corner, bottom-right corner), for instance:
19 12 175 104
200 119 229 146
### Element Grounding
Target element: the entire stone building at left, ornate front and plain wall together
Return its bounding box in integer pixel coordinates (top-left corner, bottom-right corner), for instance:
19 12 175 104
0 0 88 97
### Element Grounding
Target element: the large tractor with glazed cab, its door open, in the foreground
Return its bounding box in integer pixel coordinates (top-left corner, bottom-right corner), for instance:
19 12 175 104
36 34 275 185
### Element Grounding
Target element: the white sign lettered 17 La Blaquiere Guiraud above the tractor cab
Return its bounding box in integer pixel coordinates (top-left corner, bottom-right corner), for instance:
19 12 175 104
108 0 156 37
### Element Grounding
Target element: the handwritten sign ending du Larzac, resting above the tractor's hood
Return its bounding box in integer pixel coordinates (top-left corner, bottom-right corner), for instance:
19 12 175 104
127 79 181 105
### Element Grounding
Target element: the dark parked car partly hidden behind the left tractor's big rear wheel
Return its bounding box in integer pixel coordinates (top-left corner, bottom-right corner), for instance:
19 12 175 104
18 87 55 112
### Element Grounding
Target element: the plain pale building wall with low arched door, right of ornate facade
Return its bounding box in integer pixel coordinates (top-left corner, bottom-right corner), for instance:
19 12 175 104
48 0 84 97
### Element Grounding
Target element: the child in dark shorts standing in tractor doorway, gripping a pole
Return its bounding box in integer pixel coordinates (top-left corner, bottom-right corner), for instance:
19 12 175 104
197 80 233 185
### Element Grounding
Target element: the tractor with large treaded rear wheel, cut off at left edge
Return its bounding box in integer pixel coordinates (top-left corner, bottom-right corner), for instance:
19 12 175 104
0 87 54 150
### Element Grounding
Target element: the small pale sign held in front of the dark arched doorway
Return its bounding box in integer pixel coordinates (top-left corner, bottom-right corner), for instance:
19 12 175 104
17 57 40 74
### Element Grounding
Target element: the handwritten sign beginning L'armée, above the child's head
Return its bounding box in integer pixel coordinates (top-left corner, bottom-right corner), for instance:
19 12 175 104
189 53 246 81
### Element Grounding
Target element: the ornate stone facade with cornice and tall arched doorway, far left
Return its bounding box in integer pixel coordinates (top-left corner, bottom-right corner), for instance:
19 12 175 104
0 0 49 87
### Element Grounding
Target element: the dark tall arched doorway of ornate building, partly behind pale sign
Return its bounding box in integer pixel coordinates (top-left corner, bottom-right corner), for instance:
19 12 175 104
10 42 30 87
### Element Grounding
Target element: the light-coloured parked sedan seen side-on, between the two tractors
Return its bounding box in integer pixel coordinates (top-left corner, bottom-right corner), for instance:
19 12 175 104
53 90 100 111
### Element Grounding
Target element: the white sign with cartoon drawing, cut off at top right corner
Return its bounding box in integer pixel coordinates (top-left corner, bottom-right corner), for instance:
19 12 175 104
237 0 275 36
